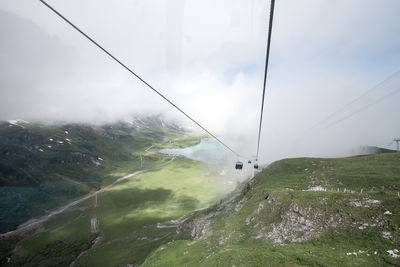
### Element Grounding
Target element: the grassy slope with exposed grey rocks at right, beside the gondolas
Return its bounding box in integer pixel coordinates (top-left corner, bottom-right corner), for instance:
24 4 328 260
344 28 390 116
143 153 400 266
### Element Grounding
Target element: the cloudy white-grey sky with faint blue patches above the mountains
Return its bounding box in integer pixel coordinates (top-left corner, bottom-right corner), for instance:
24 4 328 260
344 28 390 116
0 0 400 162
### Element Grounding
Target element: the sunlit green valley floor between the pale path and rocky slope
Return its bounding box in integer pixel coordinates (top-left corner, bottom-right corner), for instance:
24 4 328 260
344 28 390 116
0 158 231 266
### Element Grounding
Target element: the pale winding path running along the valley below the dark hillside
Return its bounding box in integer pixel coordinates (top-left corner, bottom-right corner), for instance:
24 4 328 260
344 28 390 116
0 156 176 237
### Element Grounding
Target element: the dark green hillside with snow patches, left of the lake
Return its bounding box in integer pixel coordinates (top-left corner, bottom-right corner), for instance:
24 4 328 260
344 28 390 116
0 117 198 233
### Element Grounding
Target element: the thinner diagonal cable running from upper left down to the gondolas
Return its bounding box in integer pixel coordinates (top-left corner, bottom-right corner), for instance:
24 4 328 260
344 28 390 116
39 0 241 157
